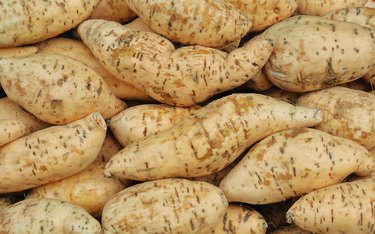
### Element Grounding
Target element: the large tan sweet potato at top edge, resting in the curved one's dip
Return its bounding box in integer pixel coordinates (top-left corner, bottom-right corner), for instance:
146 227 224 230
126 0 252 47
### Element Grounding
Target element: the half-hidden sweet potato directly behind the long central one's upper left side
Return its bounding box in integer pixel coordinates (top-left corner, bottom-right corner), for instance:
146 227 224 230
110 104 199 146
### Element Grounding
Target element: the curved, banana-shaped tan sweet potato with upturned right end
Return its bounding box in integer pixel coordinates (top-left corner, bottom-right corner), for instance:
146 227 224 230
78 20 273 106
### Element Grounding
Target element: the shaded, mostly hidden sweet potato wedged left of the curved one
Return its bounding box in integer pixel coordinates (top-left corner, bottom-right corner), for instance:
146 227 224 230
38 38 152 101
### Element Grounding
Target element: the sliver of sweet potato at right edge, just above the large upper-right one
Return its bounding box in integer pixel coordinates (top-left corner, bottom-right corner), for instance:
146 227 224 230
324 7 375 28
